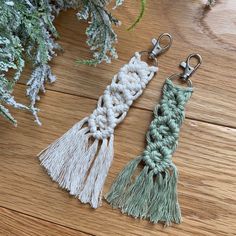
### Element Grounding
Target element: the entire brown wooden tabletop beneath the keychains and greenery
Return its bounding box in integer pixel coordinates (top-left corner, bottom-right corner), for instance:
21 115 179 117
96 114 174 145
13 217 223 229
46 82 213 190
0 0 236 236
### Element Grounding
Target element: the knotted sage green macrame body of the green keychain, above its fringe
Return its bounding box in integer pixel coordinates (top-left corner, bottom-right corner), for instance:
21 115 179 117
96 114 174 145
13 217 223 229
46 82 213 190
143 79 193 174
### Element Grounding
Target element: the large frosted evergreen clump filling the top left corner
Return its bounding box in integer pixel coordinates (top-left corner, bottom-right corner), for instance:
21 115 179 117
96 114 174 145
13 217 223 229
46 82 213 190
0 0 59 124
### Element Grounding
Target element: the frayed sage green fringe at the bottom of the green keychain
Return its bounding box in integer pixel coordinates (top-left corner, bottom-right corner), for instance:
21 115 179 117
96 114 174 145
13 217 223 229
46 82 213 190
105 157 181 226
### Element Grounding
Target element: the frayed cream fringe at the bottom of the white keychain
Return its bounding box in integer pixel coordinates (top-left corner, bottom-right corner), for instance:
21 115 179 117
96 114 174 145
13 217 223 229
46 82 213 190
38 118 114 208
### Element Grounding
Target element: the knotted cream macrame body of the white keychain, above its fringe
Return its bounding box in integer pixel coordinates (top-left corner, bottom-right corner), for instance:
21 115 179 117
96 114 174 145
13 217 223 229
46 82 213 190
88 53 157 139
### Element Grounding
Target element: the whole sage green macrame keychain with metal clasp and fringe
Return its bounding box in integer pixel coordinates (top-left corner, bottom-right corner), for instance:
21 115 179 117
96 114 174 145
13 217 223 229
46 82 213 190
105 54 202 226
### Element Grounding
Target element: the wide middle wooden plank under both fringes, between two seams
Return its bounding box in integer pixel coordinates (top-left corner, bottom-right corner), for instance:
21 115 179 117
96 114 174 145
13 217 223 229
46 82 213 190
0 85 236 235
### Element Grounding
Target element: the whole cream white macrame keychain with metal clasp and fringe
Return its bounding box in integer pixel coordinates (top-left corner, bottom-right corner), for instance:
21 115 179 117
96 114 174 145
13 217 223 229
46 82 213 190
38 33 172 208
